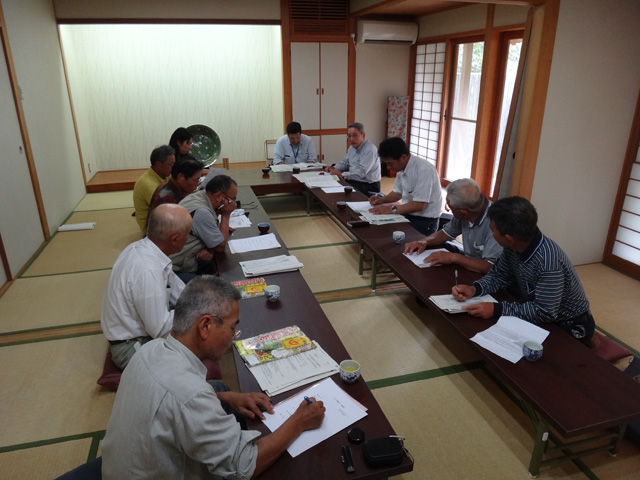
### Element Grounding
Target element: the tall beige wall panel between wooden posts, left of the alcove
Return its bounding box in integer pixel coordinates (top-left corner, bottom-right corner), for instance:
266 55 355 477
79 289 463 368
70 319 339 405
2 0 85 231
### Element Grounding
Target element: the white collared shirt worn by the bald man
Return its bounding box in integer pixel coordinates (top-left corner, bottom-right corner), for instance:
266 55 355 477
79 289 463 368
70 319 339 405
100 238 184 340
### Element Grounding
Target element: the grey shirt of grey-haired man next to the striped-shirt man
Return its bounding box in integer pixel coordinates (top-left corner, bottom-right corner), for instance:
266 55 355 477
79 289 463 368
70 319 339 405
442 198 502 263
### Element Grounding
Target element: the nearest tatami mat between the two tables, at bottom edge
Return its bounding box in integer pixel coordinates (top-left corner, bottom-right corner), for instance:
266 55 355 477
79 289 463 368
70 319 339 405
373 370 585 480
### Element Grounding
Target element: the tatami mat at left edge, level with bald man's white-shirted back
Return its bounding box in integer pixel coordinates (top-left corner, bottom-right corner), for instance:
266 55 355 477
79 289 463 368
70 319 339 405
0 270 111 333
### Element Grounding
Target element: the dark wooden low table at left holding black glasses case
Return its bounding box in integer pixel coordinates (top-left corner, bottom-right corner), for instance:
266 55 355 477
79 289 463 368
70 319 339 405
217 184 413 480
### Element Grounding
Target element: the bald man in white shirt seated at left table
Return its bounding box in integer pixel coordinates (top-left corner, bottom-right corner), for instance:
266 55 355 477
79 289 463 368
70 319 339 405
100 204 191 369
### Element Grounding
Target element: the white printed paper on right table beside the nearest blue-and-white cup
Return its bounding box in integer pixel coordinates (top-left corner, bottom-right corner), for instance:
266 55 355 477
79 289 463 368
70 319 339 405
471 316 549 363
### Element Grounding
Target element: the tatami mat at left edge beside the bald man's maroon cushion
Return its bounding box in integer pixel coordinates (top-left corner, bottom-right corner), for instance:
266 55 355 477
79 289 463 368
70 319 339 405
0 335 115 447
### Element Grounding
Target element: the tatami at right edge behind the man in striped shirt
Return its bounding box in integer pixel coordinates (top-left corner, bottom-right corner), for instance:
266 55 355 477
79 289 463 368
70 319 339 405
576 263 640 351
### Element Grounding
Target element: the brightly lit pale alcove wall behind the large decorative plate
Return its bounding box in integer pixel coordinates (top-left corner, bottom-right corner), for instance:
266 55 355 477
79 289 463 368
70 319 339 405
60 25 283 172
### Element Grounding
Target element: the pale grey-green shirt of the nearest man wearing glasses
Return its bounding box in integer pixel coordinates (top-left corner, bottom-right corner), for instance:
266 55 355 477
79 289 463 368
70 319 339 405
102 336 260 480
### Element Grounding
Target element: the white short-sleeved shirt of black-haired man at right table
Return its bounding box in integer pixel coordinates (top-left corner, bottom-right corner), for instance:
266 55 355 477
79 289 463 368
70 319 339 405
393 155 442 218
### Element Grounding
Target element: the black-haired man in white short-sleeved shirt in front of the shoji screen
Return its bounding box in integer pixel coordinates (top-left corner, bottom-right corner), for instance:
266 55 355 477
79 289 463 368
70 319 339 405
369 137 442 235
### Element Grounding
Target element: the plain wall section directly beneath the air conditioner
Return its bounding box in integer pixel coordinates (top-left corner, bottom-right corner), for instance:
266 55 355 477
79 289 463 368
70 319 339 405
356 43 410 147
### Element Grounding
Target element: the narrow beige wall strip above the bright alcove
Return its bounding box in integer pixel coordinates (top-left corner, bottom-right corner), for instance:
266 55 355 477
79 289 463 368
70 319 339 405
53 0 280 20
